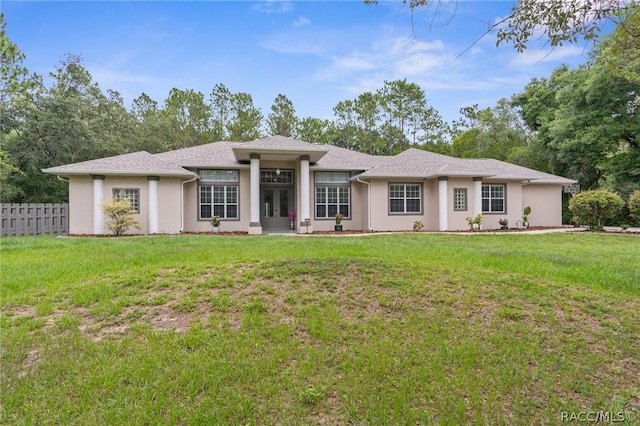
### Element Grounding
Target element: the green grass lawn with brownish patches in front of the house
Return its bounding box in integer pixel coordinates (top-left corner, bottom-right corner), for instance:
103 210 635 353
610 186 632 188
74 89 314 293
0 233 640 425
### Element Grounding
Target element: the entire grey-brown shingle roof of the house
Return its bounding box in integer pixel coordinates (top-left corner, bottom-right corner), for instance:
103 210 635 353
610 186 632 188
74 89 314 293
43 136 575 184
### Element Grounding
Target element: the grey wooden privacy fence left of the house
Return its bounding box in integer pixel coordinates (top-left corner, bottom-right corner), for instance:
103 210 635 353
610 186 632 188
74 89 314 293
0 204 69 237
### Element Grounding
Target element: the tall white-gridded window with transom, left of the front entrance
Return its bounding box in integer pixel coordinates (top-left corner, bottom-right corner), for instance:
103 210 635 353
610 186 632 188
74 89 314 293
198 170 239 220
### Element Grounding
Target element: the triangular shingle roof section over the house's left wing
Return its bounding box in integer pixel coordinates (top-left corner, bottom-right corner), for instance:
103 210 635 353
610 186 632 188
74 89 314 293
43 151 194 176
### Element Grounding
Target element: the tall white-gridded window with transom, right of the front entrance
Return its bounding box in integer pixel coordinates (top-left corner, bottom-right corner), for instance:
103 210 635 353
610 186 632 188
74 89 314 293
315 172 351 219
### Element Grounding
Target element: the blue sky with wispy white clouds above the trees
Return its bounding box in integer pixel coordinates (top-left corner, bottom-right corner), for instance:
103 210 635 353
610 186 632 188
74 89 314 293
2 0 589 121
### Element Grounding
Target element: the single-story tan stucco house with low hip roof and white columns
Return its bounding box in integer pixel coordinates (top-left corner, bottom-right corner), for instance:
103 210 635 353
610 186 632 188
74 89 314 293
43 136 575 234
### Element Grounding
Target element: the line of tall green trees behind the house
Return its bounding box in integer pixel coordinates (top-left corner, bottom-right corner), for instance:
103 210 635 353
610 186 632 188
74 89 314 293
0 6 640 213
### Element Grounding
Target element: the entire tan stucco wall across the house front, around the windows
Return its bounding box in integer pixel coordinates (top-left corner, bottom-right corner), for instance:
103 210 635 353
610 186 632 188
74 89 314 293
69 168 562 234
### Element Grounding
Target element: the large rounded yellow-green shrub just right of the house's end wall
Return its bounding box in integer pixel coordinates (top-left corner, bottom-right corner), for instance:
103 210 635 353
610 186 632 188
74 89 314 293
569 189 624 229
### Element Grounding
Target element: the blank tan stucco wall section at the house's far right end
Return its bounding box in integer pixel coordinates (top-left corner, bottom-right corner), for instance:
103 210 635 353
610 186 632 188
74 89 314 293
522 184 562 226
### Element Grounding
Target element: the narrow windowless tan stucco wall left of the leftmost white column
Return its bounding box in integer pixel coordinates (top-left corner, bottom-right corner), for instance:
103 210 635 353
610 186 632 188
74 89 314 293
69 176 93 235
